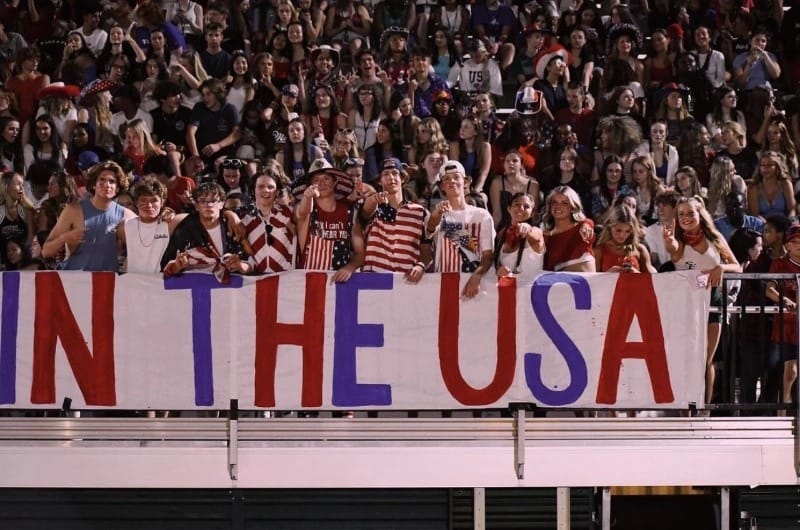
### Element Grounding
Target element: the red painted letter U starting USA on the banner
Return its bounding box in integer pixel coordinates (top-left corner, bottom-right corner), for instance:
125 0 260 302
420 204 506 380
439 273 517 405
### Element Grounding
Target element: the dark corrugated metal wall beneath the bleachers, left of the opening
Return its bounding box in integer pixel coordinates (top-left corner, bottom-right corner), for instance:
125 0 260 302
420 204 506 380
0 488 594 530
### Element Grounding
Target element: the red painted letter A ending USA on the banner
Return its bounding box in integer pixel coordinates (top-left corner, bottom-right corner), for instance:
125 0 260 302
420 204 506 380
597 274 675 404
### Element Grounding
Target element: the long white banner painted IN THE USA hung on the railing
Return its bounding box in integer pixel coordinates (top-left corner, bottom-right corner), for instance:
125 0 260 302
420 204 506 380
0 271 709 410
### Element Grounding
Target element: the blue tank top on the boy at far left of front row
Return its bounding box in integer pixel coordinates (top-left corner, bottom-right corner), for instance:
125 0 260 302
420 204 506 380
62 199 125 272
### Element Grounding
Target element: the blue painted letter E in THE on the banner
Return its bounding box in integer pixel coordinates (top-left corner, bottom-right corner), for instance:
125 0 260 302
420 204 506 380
331 273 394 407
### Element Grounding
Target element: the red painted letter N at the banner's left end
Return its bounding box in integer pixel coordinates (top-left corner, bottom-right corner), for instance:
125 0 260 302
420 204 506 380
31 272 117 405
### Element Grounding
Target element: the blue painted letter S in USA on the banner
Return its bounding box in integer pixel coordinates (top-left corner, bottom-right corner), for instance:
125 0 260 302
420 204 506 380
525 273 592 406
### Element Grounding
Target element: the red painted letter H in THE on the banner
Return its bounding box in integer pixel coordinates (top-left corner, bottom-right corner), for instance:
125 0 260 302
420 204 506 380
255 272 328 407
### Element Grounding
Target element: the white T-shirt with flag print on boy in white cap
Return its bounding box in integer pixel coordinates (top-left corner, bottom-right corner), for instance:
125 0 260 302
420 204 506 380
431 205 495 272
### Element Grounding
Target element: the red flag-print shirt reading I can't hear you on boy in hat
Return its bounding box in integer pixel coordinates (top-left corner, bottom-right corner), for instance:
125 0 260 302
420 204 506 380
301 201 355 271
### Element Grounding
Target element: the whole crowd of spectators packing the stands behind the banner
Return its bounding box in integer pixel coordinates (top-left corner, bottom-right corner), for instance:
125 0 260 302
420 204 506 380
0 0 800 410
